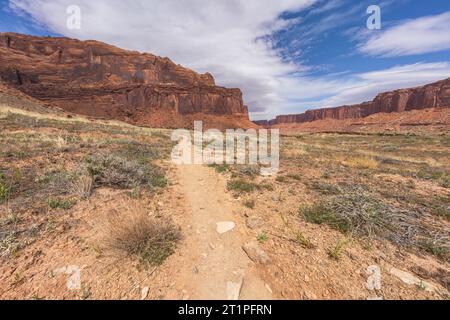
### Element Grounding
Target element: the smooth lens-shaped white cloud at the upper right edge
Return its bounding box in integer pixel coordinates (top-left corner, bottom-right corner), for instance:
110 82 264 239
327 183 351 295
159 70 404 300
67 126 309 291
359 12 450 57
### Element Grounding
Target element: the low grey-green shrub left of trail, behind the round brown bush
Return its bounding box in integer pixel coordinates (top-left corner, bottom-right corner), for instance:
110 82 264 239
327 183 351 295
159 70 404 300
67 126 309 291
86 155 167 189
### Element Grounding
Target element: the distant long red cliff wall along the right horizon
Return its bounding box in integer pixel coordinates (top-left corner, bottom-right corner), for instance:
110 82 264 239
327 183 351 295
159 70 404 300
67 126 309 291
255 78 450 127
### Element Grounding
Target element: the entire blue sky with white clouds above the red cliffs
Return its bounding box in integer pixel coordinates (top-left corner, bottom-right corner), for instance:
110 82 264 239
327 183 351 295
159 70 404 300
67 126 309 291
0 0 450 119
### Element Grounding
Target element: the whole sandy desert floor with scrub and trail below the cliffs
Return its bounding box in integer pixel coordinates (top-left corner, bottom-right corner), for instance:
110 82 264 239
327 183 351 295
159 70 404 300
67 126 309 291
0 108 450 299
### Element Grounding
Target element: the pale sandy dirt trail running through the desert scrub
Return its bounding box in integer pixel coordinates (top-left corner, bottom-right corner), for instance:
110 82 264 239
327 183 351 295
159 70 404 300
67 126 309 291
171 165 273 300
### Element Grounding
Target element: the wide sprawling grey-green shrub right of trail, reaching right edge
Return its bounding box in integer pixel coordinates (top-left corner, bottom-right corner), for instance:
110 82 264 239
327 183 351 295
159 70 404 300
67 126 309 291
299 186 450 260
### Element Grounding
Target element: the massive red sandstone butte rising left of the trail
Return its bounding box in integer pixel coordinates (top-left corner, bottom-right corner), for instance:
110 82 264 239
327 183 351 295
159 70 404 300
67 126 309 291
0 33 256 129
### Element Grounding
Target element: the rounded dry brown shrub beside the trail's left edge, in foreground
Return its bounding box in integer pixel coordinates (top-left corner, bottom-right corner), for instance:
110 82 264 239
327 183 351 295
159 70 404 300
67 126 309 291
105 208 181 267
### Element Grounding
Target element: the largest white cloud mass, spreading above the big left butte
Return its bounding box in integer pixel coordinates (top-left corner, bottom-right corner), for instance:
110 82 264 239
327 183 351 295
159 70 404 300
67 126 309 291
10 0 316 115
